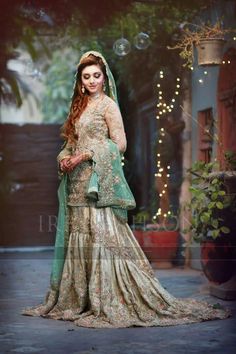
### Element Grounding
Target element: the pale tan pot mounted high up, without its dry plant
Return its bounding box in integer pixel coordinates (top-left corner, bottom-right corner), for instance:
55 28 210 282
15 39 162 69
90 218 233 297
196 38 226 66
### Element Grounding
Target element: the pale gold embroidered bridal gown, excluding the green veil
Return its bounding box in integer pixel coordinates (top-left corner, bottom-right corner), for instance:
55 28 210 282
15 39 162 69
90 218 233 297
21 96 232 328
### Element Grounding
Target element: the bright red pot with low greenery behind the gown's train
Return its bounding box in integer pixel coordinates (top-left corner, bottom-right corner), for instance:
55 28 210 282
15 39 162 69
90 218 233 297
132 211 179 269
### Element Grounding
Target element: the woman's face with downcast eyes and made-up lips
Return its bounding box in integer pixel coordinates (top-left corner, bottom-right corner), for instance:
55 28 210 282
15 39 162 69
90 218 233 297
81 65 105 94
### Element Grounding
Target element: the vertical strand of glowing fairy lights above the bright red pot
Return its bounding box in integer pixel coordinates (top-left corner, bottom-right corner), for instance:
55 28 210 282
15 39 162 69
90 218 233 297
153 70 181 223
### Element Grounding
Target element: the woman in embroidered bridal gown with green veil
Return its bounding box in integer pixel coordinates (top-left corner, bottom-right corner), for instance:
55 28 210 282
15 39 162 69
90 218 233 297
22 51 231 328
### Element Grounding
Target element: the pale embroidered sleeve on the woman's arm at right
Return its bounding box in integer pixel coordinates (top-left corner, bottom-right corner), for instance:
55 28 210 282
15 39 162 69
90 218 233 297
105 101 127 153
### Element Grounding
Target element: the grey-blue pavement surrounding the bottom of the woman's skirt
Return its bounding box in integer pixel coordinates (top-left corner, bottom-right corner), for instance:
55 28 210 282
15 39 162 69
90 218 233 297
0 251 236 354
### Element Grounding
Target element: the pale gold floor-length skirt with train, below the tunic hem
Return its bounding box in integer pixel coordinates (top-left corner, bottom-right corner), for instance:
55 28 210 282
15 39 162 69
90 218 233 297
22 206 232 328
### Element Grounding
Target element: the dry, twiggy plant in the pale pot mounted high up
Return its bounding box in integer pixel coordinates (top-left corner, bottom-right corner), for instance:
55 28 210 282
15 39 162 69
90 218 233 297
168 20 234 68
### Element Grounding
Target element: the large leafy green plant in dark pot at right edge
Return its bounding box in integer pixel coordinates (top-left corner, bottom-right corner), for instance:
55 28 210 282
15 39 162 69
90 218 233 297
184 161 236 284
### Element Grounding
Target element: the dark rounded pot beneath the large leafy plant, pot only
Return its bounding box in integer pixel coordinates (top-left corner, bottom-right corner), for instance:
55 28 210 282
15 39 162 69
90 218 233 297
201 238 235 284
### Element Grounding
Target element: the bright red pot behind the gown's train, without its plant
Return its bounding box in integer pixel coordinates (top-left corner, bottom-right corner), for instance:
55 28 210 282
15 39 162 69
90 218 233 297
134 230 179 268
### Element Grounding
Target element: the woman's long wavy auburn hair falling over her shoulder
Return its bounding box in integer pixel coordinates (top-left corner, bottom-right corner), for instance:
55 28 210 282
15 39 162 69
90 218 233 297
60 54 108 144
